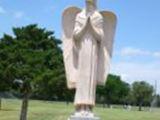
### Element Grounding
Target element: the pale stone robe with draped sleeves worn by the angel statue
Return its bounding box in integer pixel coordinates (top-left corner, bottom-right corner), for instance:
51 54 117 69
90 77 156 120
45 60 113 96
74 11 103 105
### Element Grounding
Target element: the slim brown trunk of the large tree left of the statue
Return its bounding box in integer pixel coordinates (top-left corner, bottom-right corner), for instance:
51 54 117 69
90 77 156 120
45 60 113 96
20 93 29 120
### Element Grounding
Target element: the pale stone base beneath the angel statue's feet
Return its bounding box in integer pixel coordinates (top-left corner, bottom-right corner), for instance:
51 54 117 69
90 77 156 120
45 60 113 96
68 111 100 120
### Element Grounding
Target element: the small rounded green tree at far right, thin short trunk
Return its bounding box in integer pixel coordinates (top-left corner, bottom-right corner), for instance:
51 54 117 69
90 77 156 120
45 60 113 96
131 81 154 111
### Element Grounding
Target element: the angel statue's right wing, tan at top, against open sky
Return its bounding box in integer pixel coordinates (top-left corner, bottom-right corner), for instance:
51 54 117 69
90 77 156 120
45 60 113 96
97 11 117 85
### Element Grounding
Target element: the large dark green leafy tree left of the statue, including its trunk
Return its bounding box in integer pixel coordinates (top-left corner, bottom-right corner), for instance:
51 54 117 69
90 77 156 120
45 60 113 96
0 25 65 120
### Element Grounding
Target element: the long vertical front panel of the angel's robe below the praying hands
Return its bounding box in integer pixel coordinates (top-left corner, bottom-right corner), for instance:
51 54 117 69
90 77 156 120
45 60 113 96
75 21 98 105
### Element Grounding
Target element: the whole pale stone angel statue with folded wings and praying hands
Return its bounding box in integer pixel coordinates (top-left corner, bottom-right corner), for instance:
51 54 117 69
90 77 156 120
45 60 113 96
62 0 116 118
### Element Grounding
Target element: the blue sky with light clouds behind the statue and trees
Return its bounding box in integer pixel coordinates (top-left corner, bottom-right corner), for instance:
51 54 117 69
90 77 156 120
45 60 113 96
0 0 160 93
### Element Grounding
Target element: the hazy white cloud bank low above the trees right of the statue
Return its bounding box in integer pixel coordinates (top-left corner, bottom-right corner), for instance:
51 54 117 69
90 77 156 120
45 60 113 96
111 61 160 93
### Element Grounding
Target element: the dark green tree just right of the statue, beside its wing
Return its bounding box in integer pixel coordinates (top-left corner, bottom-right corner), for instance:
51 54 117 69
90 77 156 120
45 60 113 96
97 74 130 106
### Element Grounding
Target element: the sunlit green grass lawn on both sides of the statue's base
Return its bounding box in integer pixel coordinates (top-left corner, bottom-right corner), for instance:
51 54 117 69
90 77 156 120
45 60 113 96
0 99 160 120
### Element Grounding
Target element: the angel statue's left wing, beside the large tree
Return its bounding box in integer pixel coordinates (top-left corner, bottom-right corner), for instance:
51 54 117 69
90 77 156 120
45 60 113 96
62 7 81 89
